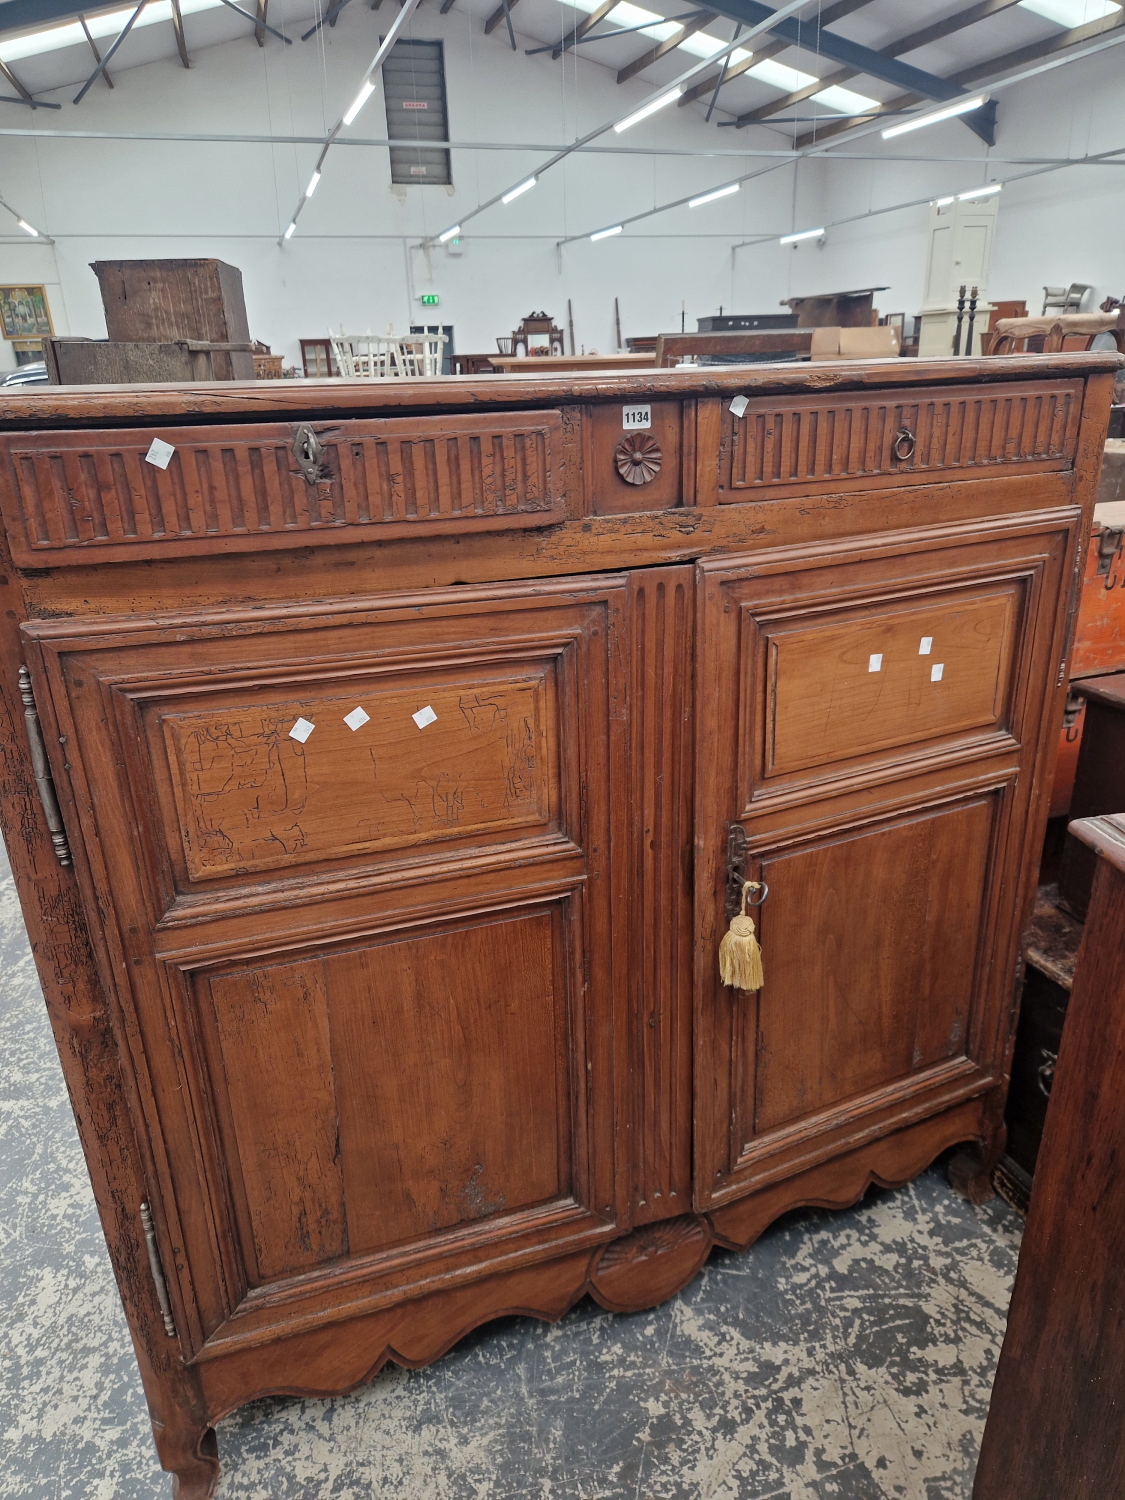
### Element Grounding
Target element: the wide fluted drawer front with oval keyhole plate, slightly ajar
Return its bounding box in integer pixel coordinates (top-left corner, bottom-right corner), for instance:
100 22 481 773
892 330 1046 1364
0 411 567 567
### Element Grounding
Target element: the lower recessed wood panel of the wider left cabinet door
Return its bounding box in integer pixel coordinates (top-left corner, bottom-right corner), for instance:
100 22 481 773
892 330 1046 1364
194 902 576 1286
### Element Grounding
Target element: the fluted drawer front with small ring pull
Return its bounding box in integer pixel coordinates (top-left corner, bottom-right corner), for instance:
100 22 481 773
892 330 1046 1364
719 380 1082 504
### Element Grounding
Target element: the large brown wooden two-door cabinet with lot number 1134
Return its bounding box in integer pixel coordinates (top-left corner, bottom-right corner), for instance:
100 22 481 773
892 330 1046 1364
0 354 1116 1497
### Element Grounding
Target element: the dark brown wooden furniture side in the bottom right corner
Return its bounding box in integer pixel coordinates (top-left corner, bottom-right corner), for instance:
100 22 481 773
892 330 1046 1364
974 818 1125 1500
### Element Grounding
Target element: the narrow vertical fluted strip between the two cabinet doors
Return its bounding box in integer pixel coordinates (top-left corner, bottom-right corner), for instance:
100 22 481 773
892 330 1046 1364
630 567 695 1224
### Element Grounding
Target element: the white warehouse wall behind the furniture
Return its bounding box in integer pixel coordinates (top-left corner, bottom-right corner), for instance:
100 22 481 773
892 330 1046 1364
0 0 1125 363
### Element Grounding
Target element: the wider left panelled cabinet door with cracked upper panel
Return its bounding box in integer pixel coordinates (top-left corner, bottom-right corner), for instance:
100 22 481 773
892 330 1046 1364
27 578 626 1352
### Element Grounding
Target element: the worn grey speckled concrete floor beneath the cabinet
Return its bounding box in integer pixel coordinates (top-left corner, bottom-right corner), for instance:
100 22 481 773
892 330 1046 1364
0 834 1020 1500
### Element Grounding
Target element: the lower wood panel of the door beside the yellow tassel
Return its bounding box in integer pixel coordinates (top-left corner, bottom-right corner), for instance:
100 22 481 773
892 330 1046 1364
750 797 995 1134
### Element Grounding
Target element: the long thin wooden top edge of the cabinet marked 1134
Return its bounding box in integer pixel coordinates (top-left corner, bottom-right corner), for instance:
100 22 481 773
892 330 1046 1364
0 353 1125 431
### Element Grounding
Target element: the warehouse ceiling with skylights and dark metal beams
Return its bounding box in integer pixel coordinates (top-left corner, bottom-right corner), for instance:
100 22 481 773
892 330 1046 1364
0 0 1125 147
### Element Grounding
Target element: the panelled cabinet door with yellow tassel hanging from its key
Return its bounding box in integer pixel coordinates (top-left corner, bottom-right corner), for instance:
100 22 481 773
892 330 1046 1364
695 512 1074 1208
